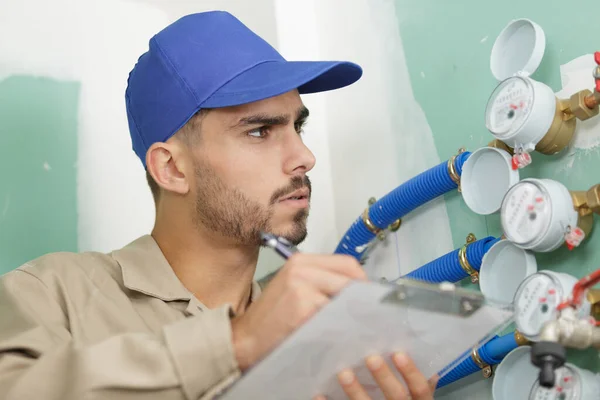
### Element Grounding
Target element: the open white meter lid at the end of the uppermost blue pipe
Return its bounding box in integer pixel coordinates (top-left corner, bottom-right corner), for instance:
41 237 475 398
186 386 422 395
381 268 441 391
460 147 519 215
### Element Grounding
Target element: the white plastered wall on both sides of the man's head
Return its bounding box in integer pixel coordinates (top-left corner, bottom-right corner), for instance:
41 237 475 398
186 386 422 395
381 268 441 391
0 0 450 272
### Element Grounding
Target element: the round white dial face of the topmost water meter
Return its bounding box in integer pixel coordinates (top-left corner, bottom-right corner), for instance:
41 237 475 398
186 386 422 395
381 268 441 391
485 77 534 139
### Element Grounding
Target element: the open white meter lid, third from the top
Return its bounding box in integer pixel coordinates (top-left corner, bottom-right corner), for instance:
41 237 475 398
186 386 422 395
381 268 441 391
479 239 537 304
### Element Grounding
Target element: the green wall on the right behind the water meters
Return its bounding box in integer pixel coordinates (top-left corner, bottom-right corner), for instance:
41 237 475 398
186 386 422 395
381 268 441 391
396 0 600 371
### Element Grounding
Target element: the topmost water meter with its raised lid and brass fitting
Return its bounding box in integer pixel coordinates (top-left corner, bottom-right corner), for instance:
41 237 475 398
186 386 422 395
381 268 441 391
485 19 600 164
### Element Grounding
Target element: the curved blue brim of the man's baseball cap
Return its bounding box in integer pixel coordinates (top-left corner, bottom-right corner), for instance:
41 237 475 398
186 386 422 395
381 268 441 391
200 61 362 108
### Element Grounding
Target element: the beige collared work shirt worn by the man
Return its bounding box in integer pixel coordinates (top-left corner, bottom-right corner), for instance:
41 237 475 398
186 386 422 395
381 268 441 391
0 236 260 400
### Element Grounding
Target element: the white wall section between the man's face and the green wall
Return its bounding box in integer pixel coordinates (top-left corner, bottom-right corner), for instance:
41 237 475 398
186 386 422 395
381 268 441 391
276 0 452 278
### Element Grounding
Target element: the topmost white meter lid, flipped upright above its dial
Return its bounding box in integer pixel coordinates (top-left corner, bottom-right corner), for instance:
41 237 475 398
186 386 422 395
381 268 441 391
490 19 546 81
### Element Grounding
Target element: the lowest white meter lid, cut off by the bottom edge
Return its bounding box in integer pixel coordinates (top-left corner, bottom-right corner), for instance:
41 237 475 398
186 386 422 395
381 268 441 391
492 346 540 400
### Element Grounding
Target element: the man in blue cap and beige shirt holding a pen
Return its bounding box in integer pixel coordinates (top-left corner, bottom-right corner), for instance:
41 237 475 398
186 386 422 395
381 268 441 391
0 12 434 400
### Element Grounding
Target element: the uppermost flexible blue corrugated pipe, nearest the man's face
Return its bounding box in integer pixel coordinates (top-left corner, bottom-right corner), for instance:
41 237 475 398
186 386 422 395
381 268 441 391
334 151 471 261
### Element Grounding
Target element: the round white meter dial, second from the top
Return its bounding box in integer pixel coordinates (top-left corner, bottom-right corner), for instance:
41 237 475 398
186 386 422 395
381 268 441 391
500 182 552 245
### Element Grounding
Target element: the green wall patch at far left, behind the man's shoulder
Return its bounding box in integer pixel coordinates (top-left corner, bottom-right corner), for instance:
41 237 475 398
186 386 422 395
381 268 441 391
0 76 79 274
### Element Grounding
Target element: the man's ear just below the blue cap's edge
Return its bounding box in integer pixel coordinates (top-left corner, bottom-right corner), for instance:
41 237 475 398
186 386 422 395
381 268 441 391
146 142 190 194
